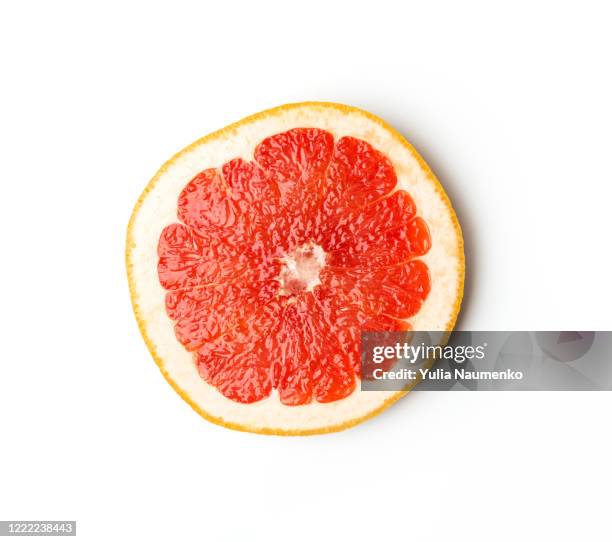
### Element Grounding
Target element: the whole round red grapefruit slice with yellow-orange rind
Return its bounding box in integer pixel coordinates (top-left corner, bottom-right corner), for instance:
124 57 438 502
126 103 464 435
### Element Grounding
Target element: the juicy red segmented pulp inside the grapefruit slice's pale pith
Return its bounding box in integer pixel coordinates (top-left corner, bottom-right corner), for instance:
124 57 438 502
158 128 431 405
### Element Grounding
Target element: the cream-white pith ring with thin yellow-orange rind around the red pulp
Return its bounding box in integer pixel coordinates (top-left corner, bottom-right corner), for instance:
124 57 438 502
128 104 463 432
